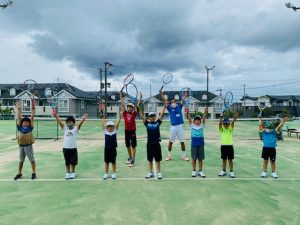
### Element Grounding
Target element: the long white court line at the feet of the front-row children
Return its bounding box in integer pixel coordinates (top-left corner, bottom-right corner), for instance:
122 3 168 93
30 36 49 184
0 177 300 182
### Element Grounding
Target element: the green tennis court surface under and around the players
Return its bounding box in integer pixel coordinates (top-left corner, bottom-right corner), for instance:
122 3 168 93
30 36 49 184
0 118 300 225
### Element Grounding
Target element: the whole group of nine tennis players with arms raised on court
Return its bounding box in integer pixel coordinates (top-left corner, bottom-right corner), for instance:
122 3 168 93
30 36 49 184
14 92 288 180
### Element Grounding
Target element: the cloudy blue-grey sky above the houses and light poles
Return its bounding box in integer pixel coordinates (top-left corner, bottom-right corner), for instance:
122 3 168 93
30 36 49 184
0 0 300 101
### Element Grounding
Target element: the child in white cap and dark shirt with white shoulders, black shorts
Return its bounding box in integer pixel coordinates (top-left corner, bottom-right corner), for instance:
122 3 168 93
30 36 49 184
102 114 122 180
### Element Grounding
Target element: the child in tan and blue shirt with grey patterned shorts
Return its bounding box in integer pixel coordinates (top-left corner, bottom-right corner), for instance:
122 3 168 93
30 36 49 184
14 100 36 180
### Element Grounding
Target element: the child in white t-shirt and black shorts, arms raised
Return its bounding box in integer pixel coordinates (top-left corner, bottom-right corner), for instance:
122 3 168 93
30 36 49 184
53 112 88 180
